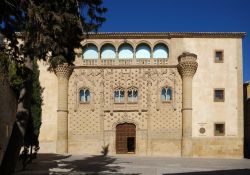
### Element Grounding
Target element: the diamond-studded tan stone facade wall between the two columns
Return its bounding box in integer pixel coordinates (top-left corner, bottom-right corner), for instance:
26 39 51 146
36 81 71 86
68 67 182 151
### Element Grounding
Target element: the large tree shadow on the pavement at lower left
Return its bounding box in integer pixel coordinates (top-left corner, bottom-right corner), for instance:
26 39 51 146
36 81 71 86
15 154 140 175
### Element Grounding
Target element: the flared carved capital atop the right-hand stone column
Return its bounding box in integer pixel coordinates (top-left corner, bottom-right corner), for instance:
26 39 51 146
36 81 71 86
177 52 198 78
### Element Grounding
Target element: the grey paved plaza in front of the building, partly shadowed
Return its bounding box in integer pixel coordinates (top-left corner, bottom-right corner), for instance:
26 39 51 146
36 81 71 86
15 154 250 175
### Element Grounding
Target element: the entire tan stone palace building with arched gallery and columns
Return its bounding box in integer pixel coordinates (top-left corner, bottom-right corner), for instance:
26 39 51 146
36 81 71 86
40 32 245 158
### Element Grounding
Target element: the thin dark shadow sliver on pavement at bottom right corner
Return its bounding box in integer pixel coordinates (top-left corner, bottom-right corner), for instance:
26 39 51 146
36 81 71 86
163 169 250 175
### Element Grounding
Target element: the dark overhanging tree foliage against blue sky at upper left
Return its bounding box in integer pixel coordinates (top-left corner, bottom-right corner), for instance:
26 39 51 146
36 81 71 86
0 0 107 68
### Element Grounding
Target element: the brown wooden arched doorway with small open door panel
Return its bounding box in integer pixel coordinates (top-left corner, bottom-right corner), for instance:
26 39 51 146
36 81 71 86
116 123 136 154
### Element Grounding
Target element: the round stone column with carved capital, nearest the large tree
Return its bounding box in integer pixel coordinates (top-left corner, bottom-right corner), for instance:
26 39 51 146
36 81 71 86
55 64 73 153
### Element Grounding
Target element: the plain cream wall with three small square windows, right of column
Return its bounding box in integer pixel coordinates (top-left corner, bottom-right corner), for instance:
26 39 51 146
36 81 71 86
184 38 244 158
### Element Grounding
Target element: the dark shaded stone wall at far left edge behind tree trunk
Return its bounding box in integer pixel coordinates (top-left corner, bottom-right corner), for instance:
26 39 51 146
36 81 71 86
0 70 17 164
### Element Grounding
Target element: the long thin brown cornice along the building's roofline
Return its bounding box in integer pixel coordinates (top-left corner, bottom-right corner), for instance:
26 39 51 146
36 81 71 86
83 32 246 39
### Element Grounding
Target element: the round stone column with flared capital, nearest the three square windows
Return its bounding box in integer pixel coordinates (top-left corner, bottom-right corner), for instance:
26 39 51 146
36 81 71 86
177 52 198 157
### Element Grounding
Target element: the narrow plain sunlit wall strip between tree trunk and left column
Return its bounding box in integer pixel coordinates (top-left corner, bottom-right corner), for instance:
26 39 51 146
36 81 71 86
38 61 58 153
